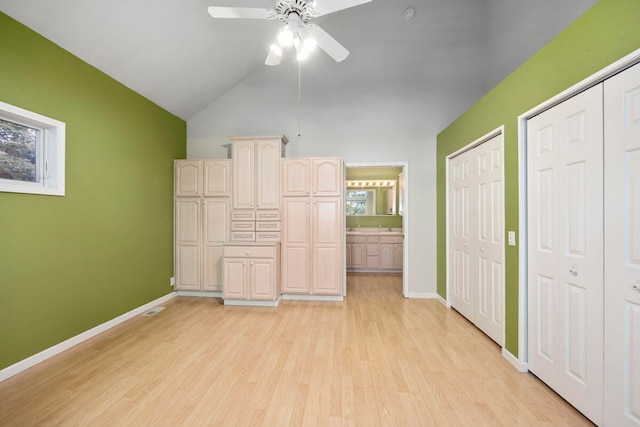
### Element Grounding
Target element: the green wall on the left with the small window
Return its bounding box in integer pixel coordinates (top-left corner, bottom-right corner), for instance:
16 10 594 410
0 13 186 369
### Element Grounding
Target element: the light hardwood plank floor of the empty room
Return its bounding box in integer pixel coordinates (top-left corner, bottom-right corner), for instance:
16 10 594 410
0 274 591 426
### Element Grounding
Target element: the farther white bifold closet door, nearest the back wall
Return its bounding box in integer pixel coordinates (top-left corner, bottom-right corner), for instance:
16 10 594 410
449 134 504 345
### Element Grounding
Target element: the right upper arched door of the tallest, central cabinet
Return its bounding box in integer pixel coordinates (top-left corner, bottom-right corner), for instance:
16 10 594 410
255 139 282 209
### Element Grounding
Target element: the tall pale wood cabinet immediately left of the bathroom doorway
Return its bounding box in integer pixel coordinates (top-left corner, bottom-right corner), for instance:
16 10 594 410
282 158 344 296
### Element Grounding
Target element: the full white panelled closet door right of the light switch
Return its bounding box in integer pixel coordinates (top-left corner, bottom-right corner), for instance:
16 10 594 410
527 84 604 424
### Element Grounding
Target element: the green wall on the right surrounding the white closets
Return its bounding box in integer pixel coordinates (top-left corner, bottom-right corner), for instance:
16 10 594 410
437 0 640 356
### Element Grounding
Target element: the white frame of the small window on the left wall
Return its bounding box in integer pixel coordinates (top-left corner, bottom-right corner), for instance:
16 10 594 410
0 101 66 196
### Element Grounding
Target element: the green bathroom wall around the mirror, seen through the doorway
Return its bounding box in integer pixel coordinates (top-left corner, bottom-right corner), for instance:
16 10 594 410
346 166 402 228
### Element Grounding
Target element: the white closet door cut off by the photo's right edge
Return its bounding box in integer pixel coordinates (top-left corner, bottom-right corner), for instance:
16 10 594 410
604 61 640 426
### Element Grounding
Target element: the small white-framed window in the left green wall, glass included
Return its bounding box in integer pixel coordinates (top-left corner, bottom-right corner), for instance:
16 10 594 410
0 102 65 196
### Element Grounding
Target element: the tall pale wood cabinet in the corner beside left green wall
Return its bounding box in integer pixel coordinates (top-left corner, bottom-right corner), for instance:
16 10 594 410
174 160 231 292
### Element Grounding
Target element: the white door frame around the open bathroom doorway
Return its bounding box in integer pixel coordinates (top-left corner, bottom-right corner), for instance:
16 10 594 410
343 161 411 298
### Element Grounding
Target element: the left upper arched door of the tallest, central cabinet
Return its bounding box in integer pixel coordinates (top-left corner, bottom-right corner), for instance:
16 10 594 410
231 140 255 209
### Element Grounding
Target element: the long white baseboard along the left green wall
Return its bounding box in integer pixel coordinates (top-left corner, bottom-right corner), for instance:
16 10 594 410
0 292 176 382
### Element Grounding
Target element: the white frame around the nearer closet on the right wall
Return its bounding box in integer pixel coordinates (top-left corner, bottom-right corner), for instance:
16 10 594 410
516 49 640 372
